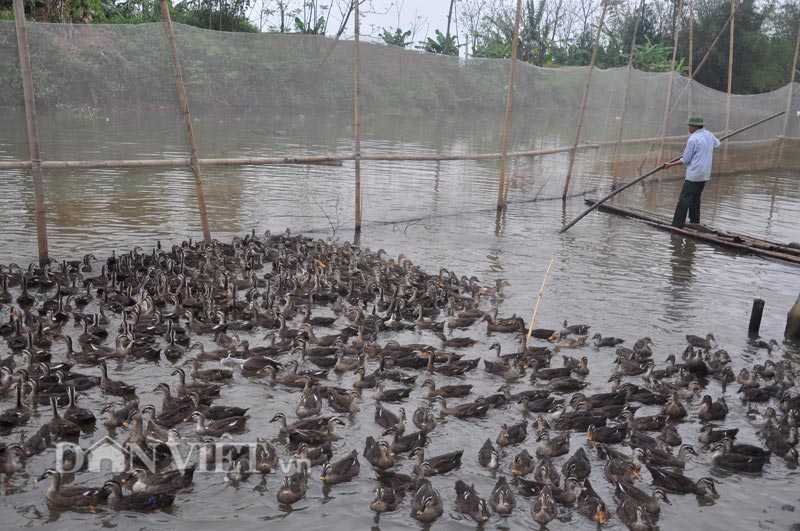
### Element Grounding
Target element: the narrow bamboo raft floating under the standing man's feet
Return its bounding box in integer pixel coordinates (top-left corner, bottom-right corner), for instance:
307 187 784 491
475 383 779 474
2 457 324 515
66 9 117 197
585 198 800 265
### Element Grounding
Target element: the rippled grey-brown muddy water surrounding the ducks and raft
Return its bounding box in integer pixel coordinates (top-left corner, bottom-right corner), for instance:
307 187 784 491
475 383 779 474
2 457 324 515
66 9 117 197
0 109 800 530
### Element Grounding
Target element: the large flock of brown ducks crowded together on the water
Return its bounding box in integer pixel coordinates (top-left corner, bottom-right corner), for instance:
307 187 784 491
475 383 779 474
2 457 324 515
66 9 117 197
0 231 800 531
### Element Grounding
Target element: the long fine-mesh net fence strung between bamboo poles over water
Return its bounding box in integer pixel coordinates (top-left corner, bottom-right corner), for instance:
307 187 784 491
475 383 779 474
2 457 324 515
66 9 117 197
0 21 800 254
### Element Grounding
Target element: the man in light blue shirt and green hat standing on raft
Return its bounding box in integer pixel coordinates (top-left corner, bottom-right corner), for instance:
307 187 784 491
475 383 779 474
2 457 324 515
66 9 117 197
664 116 719 227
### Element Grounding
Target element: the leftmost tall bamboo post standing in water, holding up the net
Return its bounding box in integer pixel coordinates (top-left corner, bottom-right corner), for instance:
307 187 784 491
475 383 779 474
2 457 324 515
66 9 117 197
14 0 50 267
